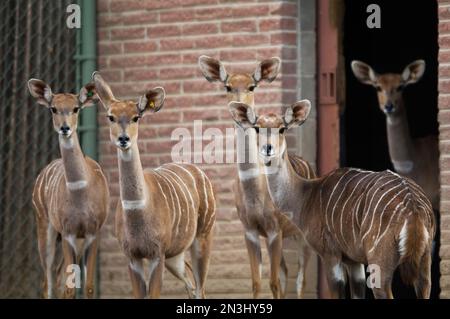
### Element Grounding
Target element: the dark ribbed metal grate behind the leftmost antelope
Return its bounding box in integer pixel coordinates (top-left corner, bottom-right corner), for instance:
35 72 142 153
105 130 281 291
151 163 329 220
0 0 76 298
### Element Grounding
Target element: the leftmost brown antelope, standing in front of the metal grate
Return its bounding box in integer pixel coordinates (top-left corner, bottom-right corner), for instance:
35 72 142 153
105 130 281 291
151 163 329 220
28 79 109 298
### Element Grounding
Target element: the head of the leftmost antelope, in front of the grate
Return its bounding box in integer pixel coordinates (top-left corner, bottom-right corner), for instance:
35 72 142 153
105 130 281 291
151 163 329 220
28 79 98 139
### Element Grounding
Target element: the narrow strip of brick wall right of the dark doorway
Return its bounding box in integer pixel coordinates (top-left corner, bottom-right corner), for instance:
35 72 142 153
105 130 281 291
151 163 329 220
438 0 450 298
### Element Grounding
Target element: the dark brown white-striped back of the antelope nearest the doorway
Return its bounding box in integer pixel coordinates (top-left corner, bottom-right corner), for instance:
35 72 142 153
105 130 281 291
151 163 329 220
316 168 434 260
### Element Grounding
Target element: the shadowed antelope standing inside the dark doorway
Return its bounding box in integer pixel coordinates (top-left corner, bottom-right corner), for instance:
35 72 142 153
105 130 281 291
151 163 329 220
352 60 440 210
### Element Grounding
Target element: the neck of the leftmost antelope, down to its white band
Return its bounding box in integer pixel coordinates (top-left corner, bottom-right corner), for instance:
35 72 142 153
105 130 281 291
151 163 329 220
59 132 89 190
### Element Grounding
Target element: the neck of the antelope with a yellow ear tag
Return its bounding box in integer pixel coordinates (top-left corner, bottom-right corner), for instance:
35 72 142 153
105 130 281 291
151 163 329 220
117 143 146 210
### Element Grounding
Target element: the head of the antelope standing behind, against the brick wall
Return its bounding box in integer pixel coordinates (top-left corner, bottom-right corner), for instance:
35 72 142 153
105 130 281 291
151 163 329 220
198 55 281 106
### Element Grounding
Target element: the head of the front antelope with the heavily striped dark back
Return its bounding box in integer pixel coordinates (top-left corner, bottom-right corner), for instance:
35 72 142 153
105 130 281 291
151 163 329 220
228 100 311 166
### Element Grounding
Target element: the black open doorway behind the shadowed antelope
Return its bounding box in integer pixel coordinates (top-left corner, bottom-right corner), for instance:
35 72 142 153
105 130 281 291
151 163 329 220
341 0 439 298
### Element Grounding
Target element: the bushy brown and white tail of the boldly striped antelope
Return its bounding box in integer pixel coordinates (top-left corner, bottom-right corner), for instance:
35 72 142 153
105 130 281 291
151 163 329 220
399 213 430 285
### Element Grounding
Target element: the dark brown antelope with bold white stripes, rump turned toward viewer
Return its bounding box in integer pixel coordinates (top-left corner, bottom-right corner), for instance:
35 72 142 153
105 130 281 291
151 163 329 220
229 100 435 298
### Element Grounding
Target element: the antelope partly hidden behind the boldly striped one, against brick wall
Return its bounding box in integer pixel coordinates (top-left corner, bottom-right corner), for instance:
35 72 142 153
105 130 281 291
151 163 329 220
199 55 315 298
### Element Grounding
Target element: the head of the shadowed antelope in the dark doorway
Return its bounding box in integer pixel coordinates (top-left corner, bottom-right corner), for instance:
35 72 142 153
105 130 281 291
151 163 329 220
351 60 425 115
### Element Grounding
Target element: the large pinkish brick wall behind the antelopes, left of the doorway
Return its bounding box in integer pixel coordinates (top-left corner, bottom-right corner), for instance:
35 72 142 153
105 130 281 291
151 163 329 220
97 0 315 298
